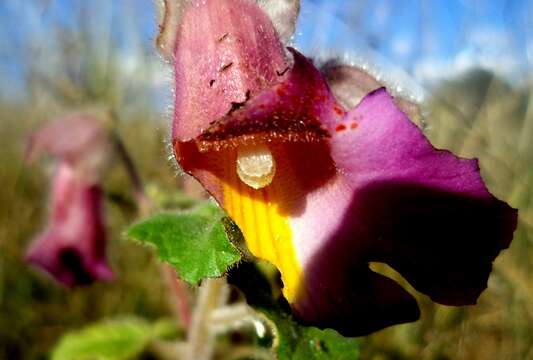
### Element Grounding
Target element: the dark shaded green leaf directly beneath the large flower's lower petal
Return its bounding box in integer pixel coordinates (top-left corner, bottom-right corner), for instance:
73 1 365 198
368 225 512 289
228 262 359 360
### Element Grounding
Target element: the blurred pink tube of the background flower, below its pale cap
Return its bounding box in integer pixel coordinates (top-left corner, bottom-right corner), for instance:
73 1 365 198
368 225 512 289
26 163 113 287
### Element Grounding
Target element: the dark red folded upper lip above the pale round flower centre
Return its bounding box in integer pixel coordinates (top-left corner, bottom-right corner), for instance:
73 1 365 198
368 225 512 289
176 49 344 152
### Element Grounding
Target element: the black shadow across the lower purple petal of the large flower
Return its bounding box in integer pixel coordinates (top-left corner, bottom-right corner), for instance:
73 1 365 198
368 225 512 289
294 181 517 336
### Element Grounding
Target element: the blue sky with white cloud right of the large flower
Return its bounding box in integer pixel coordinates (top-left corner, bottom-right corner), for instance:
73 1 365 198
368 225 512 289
299 0 533 81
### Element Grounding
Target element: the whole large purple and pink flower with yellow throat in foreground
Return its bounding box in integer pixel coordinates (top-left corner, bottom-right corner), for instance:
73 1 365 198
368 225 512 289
167 0 517 336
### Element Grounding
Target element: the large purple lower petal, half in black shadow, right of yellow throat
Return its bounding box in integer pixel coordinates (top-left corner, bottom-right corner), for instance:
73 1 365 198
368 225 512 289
288 89 517 335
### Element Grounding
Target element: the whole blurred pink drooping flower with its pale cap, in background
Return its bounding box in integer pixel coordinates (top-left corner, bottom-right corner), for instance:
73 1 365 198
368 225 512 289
26 115 113 287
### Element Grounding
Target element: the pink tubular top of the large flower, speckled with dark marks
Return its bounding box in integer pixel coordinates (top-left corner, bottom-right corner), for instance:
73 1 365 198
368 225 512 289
173 0 289 141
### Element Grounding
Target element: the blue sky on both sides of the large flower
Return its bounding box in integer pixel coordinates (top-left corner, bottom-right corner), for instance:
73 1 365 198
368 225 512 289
0 0 533 101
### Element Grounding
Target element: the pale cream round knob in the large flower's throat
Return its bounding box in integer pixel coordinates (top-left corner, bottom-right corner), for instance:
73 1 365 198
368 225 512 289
237 144 276 189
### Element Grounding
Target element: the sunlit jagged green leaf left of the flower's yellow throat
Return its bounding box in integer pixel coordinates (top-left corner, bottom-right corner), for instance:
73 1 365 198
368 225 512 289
128 204 241 285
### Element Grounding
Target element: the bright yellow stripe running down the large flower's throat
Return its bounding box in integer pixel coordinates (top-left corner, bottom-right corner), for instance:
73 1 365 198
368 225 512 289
223 157 303 303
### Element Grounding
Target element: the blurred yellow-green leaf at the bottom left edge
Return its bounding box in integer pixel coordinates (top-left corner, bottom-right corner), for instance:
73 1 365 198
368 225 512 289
52 318 153 360
